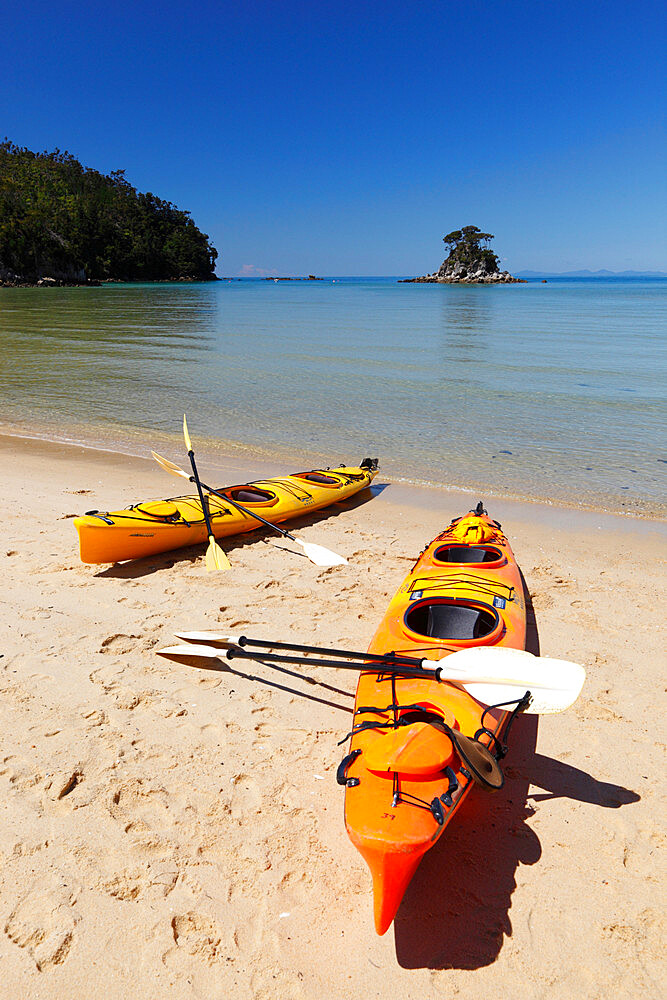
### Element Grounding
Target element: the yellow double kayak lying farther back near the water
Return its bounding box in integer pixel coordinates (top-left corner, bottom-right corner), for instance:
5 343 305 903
74 458 378 563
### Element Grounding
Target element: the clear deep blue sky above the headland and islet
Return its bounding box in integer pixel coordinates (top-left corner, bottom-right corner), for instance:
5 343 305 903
0 0 667 274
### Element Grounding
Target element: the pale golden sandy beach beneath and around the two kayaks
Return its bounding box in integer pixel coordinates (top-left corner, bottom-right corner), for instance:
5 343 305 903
0 437 666 1000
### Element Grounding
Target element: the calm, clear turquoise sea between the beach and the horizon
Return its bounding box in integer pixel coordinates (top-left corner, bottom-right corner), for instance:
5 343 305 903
0 278 667 514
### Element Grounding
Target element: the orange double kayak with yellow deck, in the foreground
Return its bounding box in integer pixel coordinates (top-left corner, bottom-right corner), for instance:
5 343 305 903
338 504 526 934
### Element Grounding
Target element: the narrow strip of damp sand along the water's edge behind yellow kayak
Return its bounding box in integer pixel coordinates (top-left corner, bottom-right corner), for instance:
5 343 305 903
0 424 667 526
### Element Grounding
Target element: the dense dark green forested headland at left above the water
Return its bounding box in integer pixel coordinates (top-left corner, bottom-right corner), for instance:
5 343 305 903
0 139 218 281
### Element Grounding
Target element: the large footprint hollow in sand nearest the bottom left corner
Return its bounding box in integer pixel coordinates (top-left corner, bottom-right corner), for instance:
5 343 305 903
4 876 79 972
